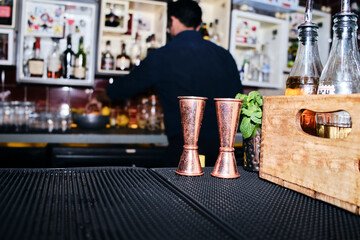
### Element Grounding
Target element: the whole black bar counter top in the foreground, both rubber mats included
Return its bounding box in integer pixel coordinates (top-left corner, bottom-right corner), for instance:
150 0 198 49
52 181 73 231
0 166 360 240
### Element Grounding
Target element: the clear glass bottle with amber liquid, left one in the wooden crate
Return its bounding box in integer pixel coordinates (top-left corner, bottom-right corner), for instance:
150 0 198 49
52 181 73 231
285 0 323 135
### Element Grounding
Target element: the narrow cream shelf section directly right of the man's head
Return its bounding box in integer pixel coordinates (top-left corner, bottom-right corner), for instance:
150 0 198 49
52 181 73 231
199 0 231 49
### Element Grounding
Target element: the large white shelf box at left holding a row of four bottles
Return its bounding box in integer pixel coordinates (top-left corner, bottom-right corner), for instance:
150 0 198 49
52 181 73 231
17 0 96 86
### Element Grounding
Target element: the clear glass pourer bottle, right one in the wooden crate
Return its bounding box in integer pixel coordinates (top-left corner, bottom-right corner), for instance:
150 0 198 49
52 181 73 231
316 1 360 138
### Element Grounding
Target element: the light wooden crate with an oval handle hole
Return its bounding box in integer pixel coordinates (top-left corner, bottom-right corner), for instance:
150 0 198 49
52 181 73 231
259 94 360 215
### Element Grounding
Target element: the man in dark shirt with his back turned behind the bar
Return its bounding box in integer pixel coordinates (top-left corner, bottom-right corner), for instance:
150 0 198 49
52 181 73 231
107 0 242 167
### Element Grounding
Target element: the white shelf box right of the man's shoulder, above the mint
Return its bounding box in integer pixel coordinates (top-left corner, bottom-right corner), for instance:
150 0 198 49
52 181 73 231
229 9 288 89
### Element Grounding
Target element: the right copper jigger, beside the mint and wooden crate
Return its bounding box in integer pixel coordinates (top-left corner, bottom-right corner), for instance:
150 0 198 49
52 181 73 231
211 98 243 178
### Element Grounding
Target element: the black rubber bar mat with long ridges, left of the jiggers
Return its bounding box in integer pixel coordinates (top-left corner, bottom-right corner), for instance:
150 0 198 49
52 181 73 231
0 167 243 240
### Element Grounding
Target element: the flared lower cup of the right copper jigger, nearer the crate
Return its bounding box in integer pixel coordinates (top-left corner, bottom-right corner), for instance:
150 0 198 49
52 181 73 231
211 152 240 178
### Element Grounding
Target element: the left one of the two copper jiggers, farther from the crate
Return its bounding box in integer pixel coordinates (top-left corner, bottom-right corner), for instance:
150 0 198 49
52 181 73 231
175 96 207 176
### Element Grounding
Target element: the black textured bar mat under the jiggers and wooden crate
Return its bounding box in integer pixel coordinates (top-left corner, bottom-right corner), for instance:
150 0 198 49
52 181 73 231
153 167 360 240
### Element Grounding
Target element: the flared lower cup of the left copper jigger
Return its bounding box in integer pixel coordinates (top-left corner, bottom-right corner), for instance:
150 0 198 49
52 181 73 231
175 149 204 176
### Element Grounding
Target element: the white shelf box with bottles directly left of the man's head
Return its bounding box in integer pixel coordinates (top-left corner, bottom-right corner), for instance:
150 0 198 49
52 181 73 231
96 0 167 76
